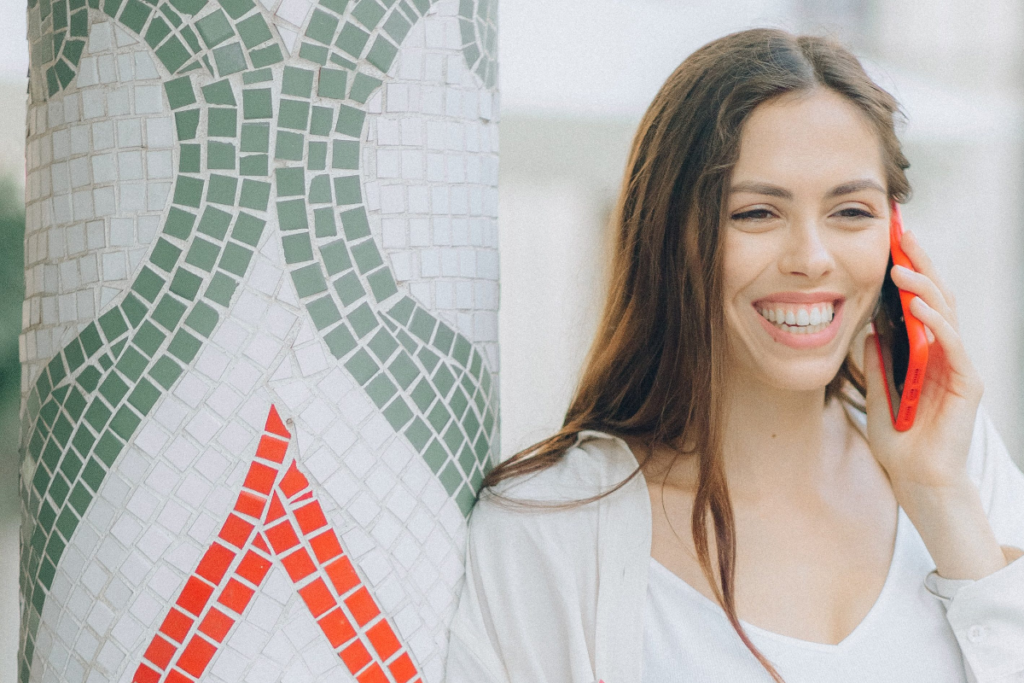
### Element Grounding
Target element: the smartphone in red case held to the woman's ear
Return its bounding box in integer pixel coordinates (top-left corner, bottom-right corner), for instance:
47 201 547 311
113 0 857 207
871 202 928 431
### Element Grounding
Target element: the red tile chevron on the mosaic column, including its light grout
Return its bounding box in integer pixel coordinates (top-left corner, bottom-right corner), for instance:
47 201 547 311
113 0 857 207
132 405 422 683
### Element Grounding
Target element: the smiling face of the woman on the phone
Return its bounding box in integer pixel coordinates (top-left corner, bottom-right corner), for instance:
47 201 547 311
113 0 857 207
723 88 889 391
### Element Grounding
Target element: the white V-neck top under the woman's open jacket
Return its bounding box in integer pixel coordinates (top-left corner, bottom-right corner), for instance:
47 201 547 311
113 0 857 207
643 509 968 683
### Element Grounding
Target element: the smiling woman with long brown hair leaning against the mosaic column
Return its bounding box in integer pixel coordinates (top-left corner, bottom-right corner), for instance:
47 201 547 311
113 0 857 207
447 30 1024 683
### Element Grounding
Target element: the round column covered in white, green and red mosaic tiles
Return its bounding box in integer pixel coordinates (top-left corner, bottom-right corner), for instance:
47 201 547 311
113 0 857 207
19 0 498 683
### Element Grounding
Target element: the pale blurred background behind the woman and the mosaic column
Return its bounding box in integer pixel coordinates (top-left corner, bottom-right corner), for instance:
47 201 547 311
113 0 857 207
0 0 1024 683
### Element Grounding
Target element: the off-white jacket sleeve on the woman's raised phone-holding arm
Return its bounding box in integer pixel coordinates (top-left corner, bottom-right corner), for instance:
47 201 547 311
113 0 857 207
926 411 1024 683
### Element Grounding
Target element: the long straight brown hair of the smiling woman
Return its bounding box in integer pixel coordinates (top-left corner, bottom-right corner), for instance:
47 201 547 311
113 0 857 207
483 29 909 681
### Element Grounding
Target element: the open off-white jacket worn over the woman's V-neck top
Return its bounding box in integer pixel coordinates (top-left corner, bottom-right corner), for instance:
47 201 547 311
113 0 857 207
446 411 1024 683
